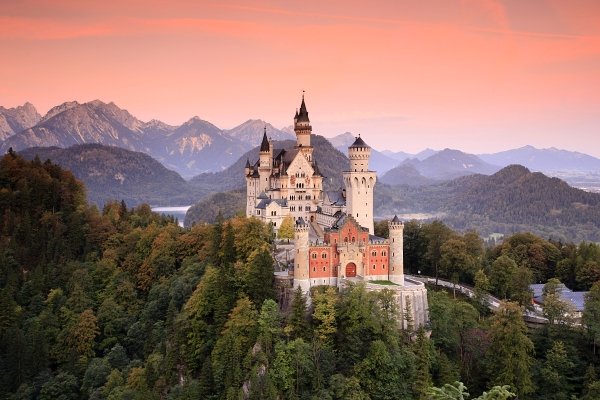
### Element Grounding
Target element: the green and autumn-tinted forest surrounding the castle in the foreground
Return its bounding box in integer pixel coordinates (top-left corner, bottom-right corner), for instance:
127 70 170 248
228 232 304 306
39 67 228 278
0 153 600 400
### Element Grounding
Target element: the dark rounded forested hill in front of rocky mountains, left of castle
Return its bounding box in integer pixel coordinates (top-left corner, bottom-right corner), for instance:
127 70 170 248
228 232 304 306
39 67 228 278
19 144 207 207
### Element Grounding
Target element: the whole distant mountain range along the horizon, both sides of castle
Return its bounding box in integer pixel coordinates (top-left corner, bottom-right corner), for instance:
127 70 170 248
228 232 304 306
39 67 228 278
0 100 600 184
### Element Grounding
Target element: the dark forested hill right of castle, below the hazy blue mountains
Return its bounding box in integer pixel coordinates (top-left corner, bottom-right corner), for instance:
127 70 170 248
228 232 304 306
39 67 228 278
375 165 600 241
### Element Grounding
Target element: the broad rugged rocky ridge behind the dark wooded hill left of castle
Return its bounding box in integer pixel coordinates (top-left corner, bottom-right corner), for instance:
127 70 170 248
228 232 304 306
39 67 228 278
0 100 251 177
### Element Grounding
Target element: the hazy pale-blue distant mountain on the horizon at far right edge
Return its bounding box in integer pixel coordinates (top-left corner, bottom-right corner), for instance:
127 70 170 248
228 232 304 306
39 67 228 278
479 146 600 172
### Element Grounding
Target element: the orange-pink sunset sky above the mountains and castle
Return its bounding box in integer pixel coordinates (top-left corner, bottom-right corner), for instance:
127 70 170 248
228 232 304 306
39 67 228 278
0 0 600 157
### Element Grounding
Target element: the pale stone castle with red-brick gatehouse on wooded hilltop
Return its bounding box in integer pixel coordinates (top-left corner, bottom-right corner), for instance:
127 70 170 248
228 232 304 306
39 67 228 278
245 96 427 326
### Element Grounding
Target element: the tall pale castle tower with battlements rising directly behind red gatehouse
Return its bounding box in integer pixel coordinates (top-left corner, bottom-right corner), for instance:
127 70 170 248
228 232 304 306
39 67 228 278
343 136 377 235
